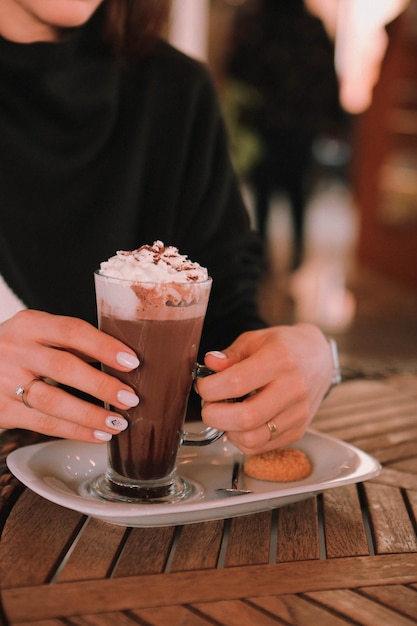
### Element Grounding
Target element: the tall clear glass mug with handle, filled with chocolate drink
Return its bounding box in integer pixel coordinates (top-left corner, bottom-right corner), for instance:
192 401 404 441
89 271 223 503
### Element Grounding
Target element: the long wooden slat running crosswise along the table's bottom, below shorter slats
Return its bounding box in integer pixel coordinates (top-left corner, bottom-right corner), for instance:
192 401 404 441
1 553 417 623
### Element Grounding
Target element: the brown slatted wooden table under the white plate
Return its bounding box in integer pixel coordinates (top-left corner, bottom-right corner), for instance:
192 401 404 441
0 375 417 626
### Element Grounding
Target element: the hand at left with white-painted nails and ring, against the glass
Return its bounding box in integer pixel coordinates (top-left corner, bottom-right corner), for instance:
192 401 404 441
0 310 139 443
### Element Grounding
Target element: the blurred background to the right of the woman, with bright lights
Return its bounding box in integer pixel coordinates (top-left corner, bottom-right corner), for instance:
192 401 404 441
168 0 417 378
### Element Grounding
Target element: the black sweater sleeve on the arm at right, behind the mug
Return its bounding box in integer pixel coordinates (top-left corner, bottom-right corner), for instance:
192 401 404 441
169 64 266 354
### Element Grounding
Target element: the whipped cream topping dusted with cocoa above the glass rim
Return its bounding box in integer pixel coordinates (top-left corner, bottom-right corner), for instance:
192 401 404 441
100 241 208 283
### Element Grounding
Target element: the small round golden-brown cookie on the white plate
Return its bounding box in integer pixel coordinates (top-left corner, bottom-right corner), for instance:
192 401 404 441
244 448 313 482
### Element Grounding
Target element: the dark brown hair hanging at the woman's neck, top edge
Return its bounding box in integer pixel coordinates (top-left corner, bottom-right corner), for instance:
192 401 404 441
101 0 171 60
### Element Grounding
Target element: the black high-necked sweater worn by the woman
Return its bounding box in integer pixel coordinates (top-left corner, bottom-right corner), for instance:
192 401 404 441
0 15 263 350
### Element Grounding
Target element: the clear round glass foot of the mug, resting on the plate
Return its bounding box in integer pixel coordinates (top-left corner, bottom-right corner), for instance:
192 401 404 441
87 470 198 504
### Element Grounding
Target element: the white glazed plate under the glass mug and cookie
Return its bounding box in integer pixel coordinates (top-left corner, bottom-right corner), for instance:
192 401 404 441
7 424 381 527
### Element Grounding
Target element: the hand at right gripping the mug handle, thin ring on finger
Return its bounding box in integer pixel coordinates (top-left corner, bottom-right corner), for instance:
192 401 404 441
196 324 333 455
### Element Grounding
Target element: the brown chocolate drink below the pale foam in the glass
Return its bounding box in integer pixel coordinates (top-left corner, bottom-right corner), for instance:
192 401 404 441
100 316 204 480
